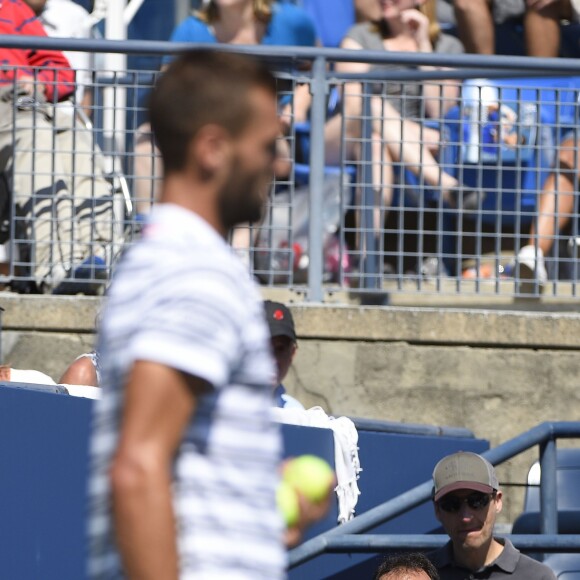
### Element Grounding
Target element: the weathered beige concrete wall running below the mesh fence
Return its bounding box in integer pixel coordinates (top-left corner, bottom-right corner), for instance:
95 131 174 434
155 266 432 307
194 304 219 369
0 294 580 520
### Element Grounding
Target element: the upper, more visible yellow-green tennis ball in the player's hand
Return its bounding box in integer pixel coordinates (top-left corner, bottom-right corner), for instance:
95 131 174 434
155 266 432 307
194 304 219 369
283 455 334 503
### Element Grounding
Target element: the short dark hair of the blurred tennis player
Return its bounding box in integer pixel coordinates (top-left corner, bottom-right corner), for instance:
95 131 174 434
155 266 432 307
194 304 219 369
149 49 276 173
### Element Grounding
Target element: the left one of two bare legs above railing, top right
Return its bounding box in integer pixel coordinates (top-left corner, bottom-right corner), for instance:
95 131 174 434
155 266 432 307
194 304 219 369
454 0 494 54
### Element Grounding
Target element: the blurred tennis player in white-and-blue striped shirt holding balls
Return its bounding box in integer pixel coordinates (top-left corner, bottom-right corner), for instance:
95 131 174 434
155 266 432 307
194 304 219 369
88 50 334 580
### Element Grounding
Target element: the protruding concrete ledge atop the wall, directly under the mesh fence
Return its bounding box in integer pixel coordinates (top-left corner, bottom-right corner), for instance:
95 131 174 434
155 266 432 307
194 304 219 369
0 292 580 349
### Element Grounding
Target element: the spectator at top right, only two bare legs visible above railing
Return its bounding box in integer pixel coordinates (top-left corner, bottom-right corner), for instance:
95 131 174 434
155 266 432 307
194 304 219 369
454 0 576 57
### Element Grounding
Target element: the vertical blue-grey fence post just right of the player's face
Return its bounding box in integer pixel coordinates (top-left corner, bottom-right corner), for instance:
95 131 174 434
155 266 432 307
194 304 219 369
306 56 327 302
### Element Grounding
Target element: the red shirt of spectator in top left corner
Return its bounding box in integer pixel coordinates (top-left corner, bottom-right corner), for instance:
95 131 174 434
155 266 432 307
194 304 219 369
0 0 75 101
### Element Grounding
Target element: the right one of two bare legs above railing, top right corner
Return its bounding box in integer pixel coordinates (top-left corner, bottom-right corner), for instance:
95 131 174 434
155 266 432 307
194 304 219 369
524 2 562 57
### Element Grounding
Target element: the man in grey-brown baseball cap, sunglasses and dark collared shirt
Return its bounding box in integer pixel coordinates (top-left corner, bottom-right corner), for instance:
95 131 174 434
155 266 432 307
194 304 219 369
429 451 556 580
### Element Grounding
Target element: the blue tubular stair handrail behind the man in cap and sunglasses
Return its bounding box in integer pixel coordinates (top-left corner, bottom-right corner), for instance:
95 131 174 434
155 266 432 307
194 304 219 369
289 422 580 568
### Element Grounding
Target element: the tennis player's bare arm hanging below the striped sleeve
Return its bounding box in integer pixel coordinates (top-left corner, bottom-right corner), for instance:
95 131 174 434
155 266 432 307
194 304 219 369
110 361 206 580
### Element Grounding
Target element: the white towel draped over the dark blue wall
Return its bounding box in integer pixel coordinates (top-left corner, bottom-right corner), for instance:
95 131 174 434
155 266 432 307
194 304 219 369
272 407 362 524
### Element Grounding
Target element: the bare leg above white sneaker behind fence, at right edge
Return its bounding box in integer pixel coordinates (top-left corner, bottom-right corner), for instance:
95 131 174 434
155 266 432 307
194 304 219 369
529 139 580 255
